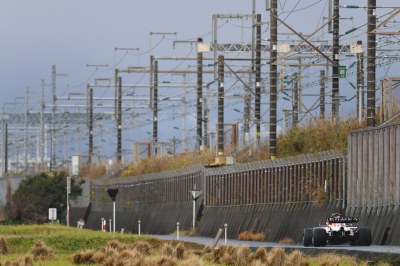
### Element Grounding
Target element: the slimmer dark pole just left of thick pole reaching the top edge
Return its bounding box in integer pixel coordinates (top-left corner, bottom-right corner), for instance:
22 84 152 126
254 14 261 146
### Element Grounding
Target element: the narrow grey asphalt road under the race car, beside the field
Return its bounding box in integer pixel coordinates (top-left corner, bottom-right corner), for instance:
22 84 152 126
154 235 400 260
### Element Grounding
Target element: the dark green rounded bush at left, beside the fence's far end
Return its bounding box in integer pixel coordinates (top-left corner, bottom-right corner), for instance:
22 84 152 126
9 172 82 223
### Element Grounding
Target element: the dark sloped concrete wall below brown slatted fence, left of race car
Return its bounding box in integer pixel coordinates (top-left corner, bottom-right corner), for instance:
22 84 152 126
197 202 340 243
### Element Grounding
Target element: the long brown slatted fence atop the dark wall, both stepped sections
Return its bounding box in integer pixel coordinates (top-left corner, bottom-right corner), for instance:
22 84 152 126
93 151 344 209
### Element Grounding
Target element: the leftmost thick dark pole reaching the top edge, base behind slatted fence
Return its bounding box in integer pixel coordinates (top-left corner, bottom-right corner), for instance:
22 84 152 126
269 0 278 160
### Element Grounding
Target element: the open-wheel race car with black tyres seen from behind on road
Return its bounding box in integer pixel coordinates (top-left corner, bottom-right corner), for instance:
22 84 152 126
303 213 371 247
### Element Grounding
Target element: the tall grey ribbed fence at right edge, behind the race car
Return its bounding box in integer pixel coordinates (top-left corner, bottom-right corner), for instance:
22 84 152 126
347 121 400 209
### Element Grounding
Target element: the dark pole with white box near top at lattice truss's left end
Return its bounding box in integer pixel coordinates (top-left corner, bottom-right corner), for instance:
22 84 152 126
196 38 203 150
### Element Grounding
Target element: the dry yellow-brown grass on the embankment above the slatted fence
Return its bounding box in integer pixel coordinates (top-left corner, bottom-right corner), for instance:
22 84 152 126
116 119 362 178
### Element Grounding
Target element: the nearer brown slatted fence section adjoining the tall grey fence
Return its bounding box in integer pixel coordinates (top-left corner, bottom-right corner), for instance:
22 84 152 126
204 151 344 206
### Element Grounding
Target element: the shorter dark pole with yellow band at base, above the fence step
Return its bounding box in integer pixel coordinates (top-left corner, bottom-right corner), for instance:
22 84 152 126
217 55 224 157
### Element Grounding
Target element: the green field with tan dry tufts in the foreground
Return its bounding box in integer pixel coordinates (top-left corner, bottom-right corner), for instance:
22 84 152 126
0 224 390 266
